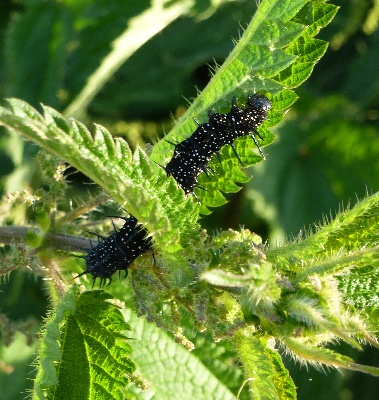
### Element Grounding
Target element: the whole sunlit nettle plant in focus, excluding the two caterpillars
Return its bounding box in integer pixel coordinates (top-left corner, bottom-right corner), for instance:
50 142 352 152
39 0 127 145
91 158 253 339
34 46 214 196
0 0 379 399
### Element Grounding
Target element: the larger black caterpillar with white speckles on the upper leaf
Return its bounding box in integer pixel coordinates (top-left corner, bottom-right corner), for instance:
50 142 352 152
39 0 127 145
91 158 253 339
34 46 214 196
164 94 271 194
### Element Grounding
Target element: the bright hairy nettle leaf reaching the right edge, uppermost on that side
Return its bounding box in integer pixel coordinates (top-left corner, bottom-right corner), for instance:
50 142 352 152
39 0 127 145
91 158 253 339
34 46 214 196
266 193 379 272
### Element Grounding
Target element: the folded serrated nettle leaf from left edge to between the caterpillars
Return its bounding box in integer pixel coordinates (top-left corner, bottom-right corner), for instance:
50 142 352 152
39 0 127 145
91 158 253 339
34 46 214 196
0 99 199 278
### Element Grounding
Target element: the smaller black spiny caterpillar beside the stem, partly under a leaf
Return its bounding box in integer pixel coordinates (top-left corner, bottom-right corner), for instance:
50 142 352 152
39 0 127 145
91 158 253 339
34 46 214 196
76 215 152 287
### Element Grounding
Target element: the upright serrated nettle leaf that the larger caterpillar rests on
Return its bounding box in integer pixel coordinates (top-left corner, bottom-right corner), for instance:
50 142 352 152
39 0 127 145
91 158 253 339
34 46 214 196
152 0 337 208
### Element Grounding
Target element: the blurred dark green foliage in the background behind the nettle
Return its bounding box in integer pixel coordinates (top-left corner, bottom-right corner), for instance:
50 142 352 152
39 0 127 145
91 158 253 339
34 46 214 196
0 0 379 400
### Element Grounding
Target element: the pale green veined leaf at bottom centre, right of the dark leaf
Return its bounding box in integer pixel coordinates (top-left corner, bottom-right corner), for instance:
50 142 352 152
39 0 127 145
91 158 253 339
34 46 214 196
126 312 235 400
